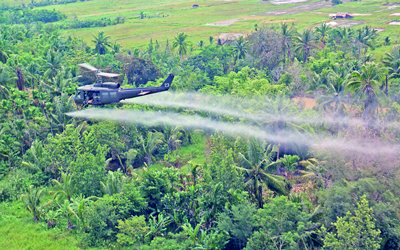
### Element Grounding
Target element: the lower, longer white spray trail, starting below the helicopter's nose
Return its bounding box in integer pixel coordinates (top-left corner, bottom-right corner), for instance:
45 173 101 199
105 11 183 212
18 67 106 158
66 109 400 154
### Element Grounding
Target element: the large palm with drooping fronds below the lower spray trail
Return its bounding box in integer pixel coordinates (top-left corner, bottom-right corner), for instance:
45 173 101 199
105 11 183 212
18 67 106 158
237 138 290 207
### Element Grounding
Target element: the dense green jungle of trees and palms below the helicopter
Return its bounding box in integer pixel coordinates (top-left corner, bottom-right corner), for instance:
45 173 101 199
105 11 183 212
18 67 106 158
0 4 400 249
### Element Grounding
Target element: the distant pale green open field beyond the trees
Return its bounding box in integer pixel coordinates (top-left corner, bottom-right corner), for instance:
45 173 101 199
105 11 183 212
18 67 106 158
6 0 400 55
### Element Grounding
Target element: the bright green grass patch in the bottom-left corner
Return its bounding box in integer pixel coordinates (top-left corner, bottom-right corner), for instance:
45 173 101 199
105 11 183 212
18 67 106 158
0 202 90 250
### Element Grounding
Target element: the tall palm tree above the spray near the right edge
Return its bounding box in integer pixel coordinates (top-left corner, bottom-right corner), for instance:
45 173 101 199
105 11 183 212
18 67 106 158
346 63 384 118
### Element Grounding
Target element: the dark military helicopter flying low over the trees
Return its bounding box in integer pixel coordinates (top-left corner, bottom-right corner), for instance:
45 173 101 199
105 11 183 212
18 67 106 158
73 63 174 105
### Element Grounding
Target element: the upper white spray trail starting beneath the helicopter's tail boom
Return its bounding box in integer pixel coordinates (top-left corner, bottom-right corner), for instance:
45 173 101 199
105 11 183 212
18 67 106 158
123 92 377 127
